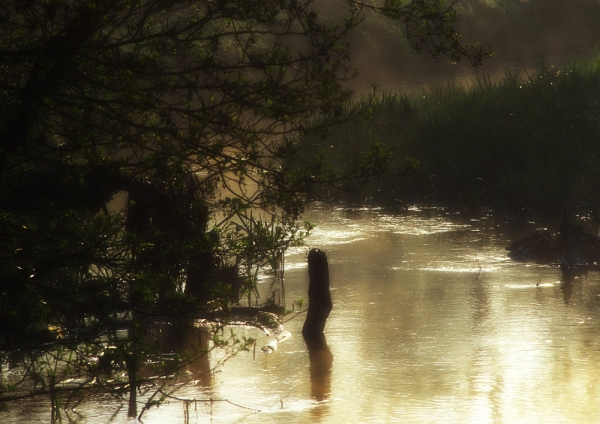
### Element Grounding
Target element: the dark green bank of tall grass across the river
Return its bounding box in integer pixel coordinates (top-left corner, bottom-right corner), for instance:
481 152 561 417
304 61 600 217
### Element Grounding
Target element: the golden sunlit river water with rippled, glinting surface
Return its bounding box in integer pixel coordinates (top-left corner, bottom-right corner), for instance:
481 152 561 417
7 207 600 424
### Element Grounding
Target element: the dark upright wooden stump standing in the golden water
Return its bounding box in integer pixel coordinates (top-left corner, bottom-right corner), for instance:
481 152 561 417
302 249 333 340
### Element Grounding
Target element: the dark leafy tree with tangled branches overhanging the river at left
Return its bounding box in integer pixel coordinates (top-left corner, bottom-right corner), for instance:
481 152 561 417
0 0 487 415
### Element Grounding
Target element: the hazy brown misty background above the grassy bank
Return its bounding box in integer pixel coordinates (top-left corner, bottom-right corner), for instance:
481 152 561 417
332 0 600 92
